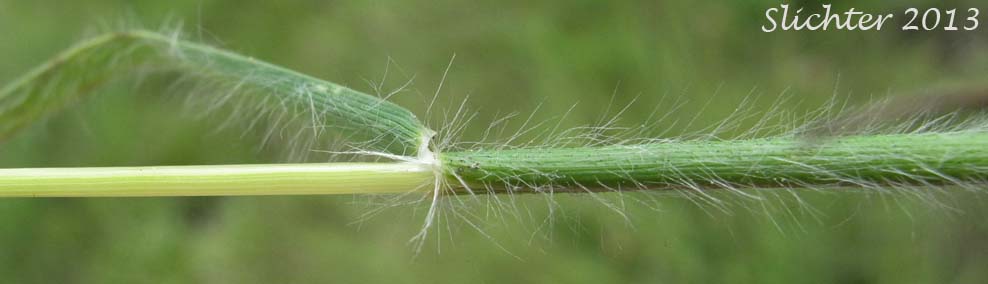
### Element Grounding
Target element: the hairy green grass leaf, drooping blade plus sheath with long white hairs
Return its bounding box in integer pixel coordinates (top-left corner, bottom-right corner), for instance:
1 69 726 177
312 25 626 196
0 28 988 253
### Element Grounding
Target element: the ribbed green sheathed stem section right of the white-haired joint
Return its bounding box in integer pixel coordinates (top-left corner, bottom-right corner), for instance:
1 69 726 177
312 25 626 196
441 132 988 191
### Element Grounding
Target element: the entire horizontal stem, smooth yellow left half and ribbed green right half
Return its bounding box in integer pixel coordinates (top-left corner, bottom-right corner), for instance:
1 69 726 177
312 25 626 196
0 132 988 197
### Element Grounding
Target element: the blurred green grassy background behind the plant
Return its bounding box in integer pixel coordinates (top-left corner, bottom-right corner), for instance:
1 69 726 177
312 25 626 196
0 0 988 283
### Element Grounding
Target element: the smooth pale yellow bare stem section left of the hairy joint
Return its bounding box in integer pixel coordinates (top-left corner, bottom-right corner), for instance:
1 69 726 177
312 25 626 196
0 163 434 197
